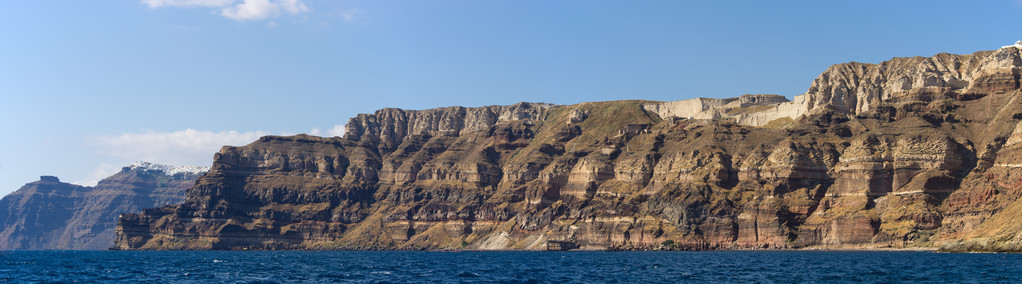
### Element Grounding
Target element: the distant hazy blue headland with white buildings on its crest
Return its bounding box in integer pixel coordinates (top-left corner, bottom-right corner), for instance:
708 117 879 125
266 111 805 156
0 162 205 250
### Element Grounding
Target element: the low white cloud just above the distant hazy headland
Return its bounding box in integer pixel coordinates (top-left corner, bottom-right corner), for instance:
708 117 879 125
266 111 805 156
89 129 270 166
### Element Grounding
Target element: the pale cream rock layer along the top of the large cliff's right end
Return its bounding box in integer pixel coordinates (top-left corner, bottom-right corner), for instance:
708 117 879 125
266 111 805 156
644 47 1022 127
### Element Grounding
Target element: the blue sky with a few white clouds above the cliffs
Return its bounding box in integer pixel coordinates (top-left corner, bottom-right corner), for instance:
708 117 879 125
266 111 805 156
0 0 1022 195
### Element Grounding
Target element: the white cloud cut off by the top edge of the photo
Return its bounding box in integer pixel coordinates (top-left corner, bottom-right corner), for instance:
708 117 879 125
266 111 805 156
142 0 312 21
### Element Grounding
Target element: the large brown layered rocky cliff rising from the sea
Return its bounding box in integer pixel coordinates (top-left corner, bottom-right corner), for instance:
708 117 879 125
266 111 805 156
115 47 1022 250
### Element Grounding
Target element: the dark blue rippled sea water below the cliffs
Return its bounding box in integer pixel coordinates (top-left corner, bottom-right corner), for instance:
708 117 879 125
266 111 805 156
0 251 1022 283
